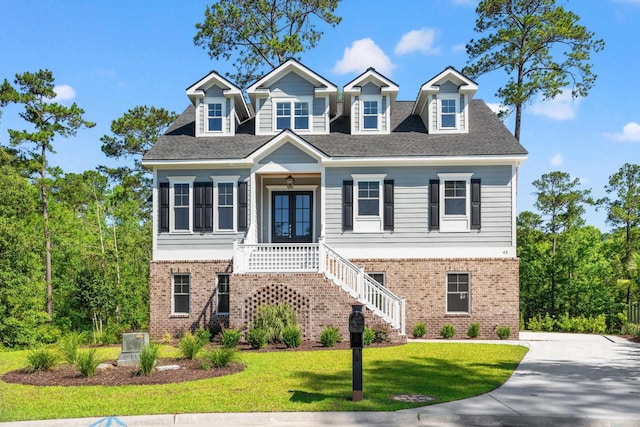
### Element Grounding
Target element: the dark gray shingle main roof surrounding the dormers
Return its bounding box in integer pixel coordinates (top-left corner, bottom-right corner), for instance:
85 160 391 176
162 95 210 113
143 100 527 161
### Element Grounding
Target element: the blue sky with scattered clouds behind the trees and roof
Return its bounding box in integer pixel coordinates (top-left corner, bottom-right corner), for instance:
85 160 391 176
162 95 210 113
0 0 640 231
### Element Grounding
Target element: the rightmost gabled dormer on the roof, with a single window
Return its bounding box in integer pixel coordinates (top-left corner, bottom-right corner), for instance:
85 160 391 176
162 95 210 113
413 67 478 133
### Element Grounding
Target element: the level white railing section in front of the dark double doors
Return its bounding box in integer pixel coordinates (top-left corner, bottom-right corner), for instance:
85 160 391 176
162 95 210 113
233 243 319 273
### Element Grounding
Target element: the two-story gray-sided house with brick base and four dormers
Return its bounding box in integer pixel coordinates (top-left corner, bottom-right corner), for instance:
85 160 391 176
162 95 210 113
143 60 527 339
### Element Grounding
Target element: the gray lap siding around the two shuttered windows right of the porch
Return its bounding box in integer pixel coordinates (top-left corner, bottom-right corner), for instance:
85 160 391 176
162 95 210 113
325 166 512 248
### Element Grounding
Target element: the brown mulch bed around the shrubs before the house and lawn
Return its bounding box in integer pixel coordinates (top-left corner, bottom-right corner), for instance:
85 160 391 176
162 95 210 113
1 341 394 386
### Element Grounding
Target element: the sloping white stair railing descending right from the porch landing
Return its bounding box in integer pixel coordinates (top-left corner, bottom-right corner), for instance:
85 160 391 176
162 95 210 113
320 243 406 335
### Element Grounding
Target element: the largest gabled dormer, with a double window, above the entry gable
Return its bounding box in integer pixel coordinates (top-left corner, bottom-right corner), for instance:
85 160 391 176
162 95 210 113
247 59 338 135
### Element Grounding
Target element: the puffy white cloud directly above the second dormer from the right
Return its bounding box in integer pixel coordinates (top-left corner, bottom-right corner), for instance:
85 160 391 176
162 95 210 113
333 37 396 77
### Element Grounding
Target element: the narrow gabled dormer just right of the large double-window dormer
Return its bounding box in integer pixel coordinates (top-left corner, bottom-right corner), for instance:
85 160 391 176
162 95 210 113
342 68 399 135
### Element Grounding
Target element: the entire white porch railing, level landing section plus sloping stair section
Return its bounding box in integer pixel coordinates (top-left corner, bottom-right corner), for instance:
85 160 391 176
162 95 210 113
233 242 406 335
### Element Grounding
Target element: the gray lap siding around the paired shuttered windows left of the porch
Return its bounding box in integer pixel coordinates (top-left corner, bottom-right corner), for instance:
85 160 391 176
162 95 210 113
154 169 253 253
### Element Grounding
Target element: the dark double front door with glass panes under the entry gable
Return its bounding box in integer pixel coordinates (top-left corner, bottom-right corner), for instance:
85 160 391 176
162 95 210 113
271 191 313 243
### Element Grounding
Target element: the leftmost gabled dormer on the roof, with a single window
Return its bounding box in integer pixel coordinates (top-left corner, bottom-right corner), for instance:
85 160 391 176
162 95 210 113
187 71 249 137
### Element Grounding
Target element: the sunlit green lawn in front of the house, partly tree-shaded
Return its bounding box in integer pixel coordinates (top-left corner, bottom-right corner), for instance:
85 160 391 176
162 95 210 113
0 343 527 421
